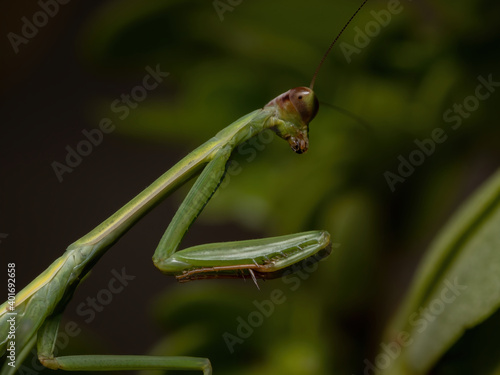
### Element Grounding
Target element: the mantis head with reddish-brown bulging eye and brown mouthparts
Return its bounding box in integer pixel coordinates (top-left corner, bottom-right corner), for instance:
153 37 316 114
266 87 319 154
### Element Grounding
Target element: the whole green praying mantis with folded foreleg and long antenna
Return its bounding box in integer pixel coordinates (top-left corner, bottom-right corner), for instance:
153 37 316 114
0 0 367 375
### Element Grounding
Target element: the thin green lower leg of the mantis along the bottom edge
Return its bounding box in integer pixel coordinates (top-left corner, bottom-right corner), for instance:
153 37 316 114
37 314 212 375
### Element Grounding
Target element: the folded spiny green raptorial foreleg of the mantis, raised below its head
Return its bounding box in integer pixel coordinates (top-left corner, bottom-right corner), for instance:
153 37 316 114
153 146 331 281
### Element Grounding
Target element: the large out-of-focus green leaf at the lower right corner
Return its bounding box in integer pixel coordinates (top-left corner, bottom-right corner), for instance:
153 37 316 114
380 172 500 374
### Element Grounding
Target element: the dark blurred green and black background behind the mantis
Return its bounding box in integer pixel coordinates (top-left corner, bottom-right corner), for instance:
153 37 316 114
0 0 500 375
